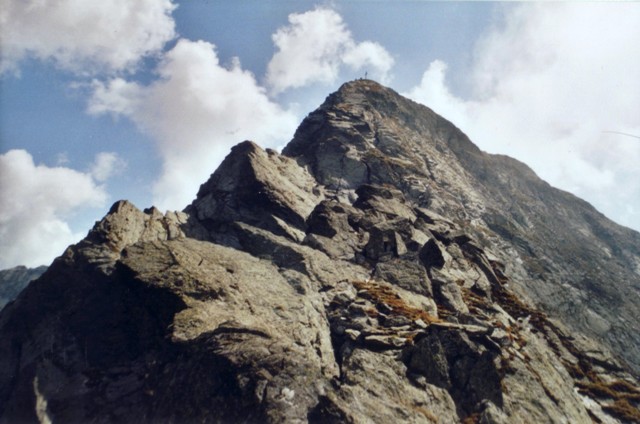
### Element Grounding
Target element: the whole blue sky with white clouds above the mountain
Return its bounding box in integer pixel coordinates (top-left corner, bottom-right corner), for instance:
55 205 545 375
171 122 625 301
0 0 640 268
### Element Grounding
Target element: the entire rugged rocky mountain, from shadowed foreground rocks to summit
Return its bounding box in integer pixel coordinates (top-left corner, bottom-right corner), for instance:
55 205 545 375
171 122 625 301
0 80 640 423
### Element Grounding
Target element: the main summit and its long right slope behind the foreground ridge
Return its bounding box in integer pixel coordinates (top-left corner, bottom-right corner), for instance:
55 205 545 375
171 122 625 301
283 81 640 373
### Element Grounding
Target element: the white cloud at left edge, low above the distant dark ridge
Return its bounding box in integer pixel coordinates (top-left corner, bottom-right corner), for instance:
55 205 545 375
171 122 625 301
0 150 107 269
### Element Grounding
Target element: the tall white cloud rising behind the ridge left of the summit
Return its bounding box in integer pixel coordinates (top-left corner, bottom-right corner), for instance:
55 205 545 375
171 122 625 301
88 39 297 209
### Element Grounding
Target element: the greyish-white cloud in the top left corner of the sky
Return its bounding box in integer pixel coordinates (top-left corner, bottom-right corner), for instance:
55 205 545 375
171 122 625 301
0 0 176 74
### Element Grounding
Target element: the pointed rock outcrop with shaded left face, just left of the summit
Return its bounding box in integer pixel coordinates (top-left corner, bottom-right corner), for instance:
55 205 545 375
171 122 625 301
186 141 322 241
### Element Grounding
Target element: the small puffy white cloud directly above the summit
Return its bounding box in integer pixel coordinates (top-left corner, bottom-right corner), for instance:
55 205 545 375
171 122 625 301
266 8 394 94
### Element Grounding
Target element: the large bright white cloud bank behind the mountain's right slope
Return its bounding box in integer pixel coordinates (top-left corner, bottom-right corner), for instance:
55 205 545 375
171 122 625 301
407 3 640 229
